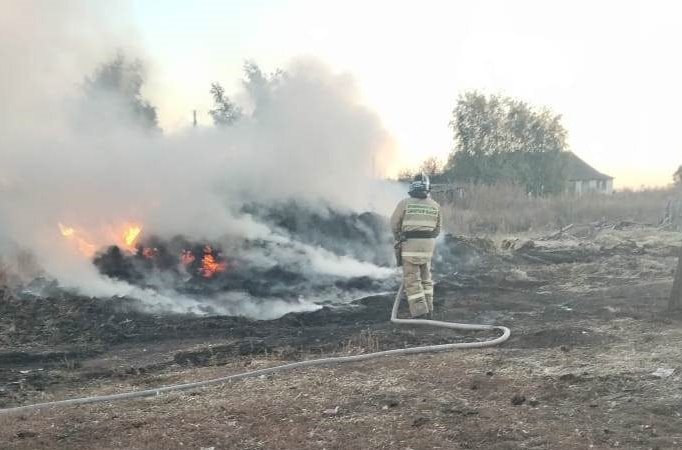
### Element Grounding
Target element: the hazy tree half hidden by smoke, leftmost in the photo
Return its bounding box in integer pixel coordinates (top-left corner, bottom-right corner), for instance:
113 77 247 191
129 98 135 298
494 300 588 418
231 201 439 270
81 52 159 131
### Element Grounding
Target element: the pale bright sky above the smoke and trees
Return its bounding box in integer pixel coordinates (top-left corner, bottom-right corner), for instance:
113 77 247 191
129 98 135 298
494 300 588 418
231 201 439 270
131 0 682 187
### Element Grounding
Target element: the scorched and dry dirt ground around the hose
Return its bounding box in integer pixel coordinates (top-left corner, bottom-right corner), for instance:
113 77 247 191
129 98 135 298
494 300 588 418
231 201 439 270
0 225 682 450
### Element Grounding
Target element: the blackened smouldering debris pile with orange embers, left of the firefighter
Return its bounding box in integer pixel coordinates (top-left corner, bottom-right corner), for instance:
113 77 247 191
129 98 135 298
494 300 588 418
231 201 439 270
93 202 396 302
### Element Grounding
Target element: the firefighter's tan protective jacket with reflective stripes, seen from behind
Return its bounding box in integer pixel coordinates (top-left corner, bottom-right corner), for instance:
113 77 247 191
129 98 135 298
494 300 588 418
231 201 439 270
391 197 442 264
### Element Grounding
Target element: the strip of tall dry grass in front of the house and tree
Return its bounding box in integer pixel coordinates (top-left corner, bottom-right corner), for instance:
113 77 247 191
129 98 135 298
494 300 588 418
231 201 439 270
433 185 682 235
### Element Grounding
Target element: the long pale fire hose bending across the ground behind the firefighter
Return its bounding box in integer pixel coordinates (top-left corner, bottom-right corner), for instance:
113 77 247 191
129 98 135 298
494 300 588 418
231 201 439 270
0 284 510 414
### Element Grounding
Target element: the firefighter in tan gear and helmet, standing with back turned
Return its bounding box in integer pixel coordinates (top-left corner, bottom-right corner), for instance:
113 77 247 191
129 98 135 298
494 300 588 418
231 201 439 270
391 173 442 319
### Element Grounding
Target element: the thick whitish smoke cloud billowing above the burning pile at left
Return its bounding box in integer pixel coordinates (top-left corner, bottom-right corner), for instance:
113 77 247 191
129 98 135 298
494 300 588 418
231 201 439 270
0 2 400 314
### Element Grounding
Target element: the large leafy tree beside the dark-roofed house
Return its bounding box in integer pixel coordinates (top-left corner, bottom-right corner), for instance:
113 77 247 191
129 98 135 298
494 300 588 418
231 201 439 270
446 91 567 194
